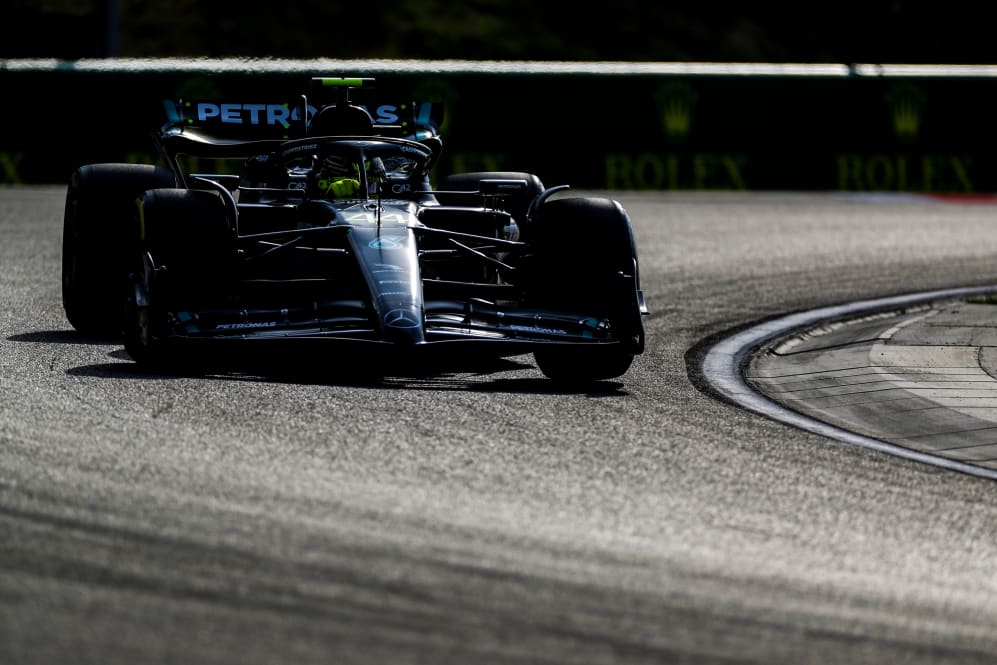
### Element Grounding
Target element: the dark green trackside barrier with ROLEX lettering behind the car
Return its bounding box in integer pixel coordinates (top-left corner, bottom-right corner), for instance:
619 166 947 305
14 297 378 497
0 59 997 195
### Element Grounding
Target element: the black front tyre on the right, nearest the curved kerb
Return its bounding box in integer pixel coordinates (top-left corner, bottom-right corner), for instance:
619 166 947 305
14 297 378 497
527 198 644 383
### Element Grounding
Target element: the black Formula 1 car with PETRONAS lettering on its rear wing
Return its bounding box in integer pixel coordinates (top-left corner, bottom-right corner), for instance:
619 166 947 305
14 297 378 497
62 78 648 382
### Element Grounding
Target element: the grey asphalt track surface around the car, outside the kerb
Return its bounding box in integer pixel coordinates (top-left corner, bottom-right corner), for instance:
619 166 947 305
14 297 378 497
0 187 997 665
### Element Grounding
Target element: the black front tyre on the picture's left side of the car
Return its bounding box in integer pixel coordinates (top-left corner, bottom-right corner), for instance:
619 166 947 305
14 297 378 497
124 189 235 369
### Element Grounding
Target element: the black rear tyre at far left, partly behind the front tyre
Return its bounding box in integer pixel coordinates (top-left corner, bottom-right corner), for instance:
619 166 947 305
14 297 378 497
62 164 175 337
